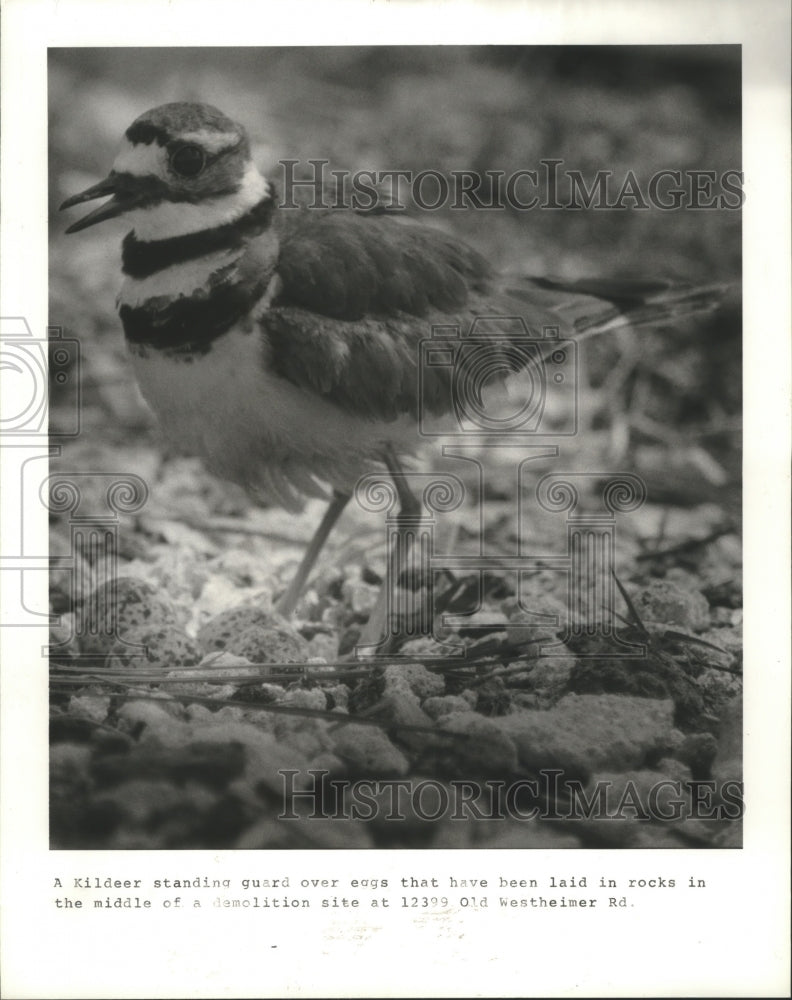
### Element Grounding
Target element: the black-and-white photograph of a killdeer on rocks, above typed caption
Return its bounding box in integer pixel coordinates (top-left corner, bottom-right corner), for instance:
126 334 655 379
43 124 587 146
49 46 744 849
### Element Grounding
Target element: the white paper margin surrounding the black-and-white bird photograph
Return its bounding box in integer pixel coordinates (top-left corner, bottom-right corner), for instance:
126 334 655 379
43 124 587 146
0 0 790 998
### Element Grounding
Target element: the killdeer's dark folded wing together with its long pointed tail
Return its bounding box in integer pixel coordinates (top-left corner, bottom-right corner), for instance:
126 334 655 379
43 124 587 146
261 210 724 420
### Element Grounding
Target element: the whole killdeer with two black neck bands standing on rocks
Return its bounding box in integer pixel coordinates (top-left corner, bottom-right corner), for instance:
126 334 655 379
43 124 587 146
61 103 724 641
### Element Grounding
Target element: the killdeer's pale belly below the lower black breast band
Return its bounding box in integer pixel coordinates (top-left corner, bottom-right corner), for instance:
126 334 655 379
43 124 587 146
127 330 416 507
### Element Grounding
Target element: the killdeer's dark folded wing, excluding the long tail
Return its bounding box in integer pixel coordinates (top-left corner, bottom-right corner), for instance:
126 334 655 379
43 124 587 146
261 211 559 420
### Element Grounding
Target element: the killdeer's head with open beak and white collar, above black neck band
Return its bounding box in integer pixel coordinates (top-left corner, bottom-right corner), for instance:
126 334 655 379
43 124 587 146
61 103 270 240
